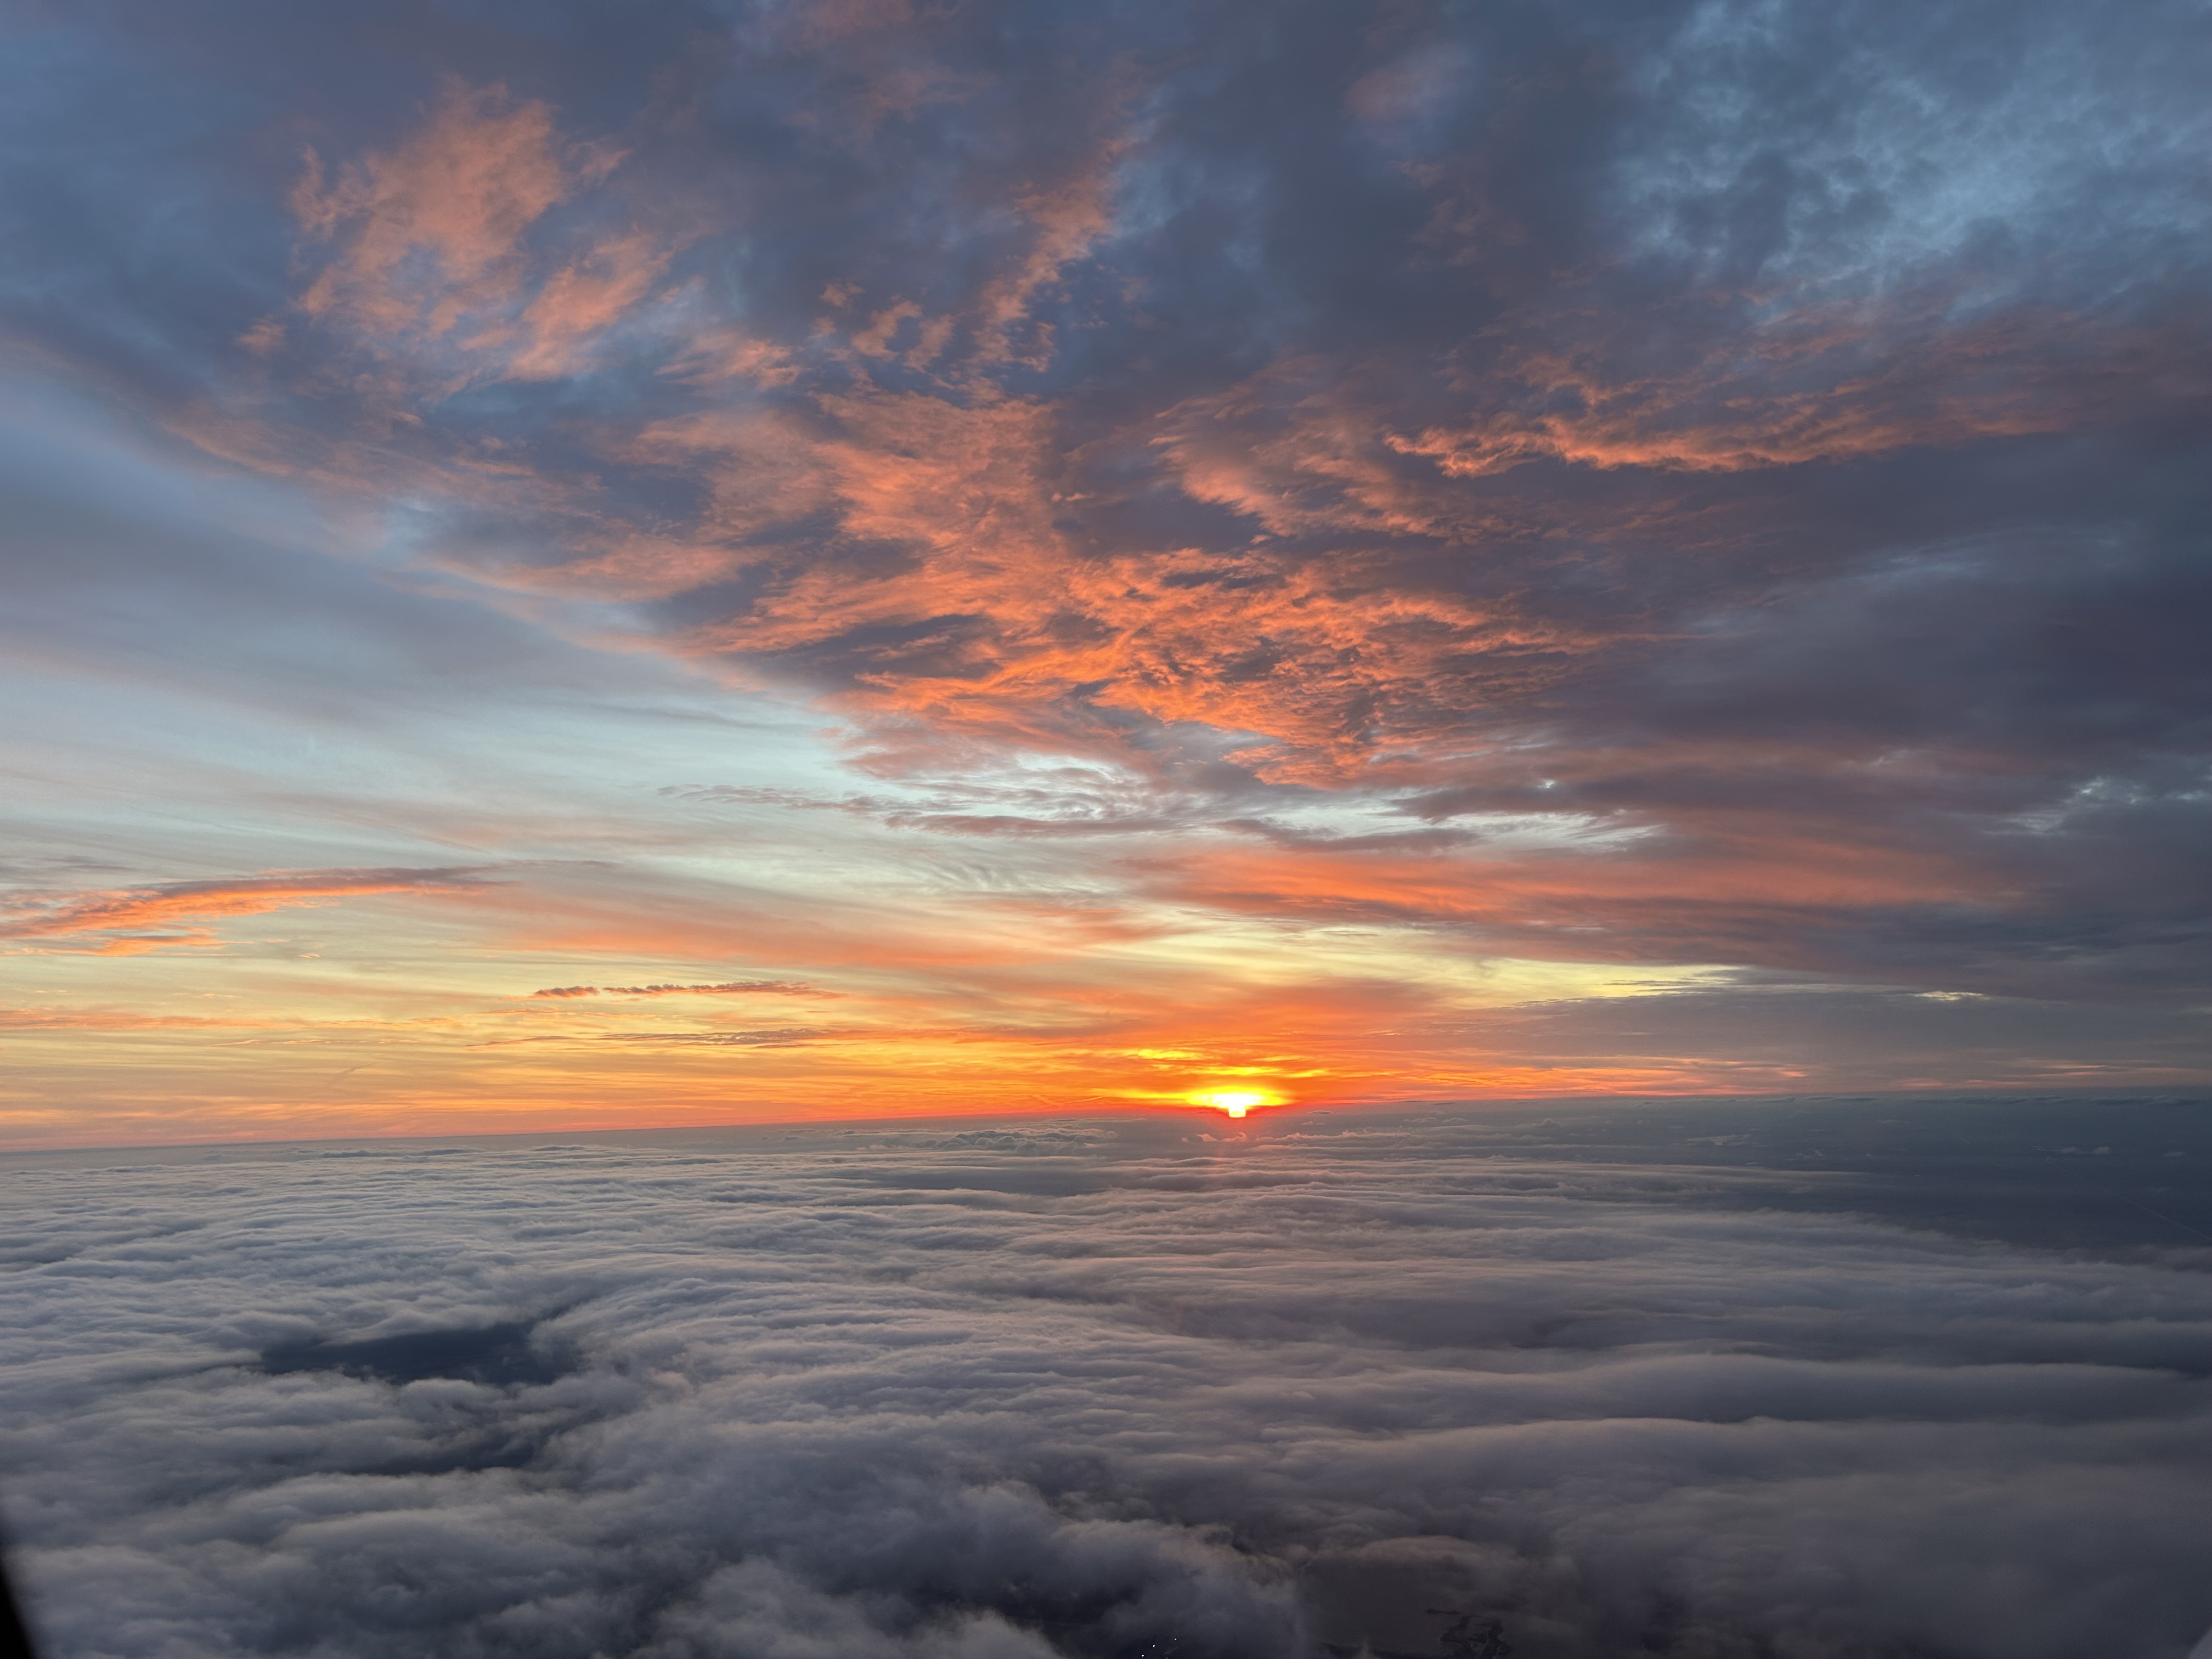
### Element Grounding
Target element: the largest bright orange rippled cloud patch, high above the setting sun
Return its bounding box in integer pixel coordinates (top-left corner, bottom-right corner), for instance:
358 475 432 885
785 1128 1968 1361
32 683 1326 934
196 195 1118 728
628 392 1590 781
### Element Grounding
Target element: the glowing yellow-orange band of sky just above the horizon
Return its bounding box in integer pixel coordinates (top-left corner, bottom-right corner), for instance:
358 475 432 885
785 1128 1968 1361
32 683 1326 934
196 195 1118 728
0 830 2190 1146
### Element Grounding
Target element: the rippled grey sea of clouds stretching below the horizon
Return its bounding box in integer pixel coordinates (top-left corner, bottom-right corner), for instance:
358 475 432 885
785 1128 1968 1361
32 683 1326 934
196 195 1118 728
0 1102 2212 1659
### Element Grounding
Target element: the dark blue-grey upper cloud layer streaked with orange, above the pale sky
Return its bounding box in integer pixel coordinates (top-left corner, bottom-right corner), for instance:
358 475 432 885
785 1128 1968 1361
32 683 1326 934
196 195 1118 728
7 0 2212 1124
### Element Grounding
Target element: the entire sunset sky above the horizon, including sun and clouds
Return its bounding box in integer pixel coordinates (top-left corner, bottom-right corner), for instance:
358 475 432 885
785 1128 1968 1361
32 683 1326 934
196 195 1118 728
0 0 2212 1146
